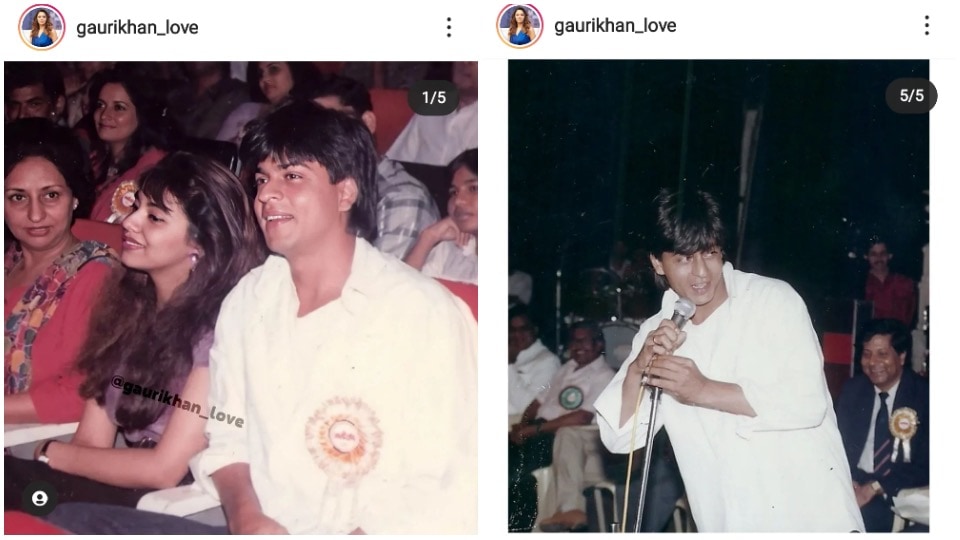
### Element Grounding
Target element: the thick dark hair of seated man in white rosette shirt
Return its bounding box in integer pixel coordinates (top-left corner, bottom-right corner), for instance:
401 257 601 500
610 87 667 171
240 102 377 241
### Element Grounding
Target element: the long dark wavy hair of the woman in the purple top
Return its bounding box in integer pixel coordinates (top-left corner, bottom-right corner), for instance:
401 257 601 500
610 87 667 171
78 152 266 429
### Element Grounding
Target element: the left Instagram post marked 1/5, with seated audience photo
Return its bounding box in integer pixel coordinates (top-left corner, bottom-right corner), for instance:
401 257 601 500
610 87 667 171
3 1 479 535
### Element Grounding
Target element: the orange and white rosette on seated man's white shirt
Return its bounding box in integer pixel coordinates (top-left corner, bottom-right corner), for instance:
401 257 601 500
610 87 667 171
306 397 383 484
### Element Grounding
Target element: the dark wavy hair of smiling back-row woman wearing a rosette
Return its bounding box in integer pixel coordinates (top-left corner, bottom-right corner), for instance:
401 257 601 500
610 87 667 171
89 63 179 190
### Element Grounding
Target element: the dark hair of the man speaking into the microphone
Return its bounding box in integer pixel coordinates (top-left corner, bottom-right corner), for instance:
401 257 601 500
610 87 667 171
649 189 726 289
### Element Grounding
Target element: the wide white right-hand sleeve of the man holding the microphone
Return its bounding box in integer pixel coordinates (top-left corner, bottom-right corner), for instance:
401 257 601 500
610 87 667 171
736 283 831 438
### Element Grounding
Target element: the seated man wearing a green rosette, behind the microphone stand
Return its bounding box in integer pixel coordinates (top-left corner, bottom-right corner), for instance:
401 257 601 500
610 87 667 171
508 322 614 530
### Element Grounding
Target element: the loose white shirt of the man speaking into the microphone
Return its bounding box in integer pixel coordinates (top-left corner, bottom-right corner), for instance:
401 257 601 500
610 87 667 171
595 263 863 532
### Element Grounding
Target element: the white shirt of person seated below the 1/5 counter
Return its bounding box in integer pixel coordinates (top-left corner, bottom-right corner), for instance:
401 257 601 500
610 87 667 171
387 102 478 167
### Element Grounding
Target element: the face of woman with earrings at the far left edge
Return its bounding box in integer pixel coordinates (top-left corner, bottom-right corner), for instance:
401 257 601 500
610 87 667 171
3 157 76 255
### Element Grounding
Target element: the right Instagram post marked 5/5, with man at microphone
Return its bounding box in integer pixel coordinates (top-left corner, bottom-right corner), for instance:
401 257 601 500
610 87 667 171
502 2 957 533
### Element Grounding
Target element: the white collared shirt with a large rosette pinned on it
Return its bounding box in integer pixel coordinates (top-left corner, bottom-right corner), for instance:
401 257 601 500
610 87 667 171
194 239 477 534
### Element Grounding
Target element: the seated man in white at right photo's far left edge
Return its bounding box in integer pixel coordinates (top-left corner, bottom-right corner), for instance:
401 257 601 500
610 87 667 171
507 304 560 416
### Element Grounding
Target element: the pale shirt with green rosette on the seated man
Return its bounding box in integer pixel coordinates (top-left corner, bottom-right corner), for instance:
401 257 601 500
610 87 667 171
537 355 614 420
